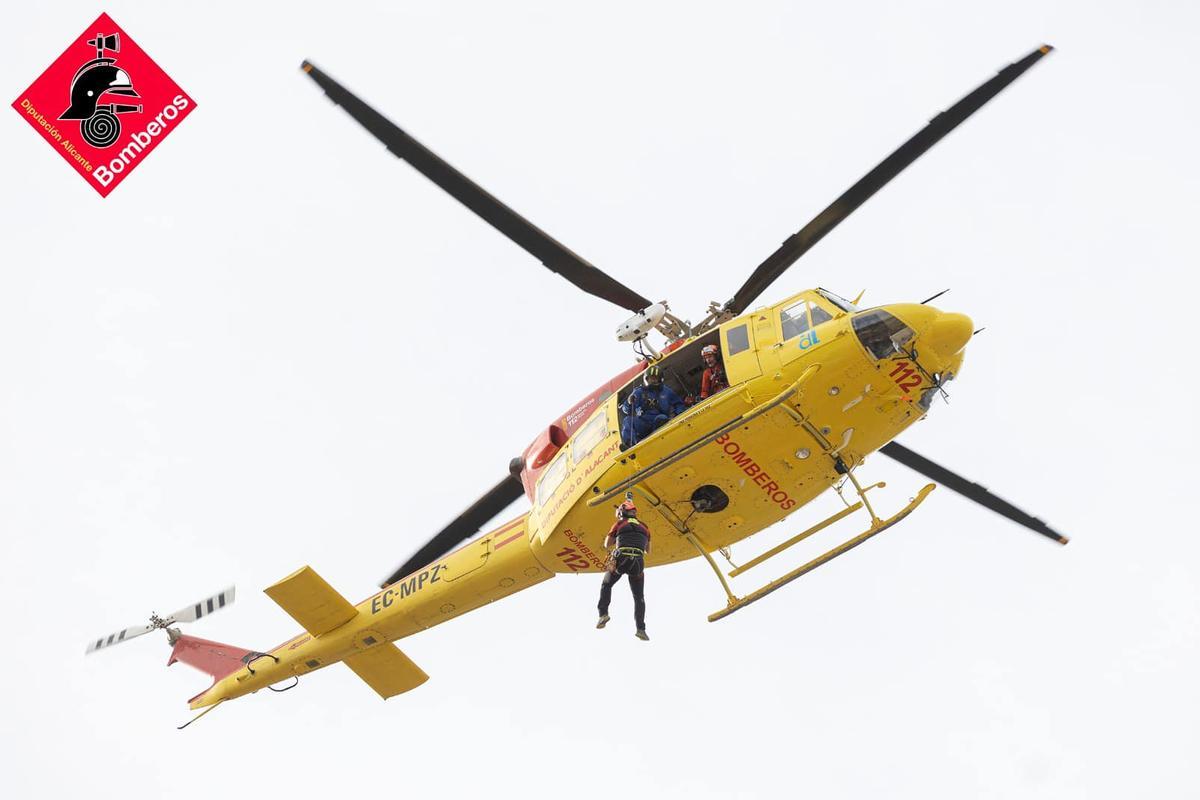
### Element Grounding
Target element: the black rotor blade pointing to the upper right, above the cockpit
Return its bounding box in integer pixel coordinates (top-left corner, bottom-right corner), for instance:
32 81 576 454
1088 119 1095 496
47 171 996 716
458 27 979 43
725 44 1054 314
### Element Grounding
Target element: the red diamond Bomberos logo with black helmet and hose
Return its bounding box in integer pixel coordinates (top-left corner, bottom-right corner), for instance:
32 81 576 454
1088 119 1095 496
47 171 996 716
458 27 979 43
12 14 196 197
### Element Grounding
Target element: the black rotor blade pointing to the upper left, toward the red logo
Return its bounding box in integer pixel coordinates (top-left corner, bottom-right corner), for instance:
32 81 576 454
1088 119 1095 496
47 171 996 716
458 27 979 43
300 61 650 312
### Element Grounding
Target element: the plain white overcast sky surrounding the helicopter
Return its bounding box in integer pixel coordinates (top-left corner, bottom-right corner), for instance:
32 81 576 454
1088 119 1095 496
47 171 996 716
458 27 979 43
0 0 1200 800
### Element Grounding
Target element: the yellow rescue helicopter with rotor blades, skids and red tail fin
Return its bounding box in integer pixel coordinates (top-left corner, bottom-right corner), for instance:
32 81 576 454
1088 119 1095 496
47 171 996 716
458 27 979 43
88 46 1067 727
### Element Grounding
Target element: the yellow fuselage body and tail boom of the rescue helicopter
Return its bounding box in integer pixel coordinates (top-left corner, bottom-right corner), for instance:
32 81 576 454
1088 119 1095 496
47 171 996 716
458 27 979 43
192 291 971 708
